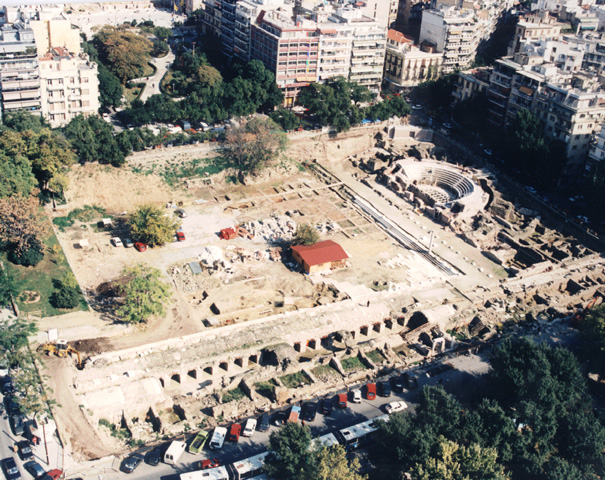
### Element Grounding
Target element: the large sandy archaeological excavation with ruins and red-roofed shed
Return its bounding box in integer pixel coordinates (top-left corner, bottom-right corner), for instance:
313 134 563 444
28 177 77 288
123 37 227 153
41 123 605 459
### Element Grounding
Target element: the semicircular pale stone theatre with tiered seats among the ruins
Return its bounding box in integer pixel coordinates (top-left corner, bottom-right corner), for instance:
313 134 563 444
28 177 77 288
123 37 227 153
385 158 485 216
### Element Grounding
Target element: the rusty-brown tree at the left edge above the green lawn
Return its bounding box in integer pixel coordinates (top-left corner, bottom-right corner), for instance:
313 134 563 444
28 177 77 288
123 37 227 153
0 196 50 256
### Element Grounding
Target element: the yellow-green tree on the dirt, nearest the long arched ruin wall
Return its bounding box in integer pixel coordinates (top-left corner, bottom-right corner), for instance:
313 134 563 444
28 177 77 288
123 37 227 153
116 265 171 324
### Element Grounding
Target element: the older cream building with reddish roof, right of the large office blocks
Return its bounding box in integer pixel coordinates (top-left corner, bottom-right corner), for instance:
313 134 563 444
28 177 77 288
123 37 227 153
384 30 443 92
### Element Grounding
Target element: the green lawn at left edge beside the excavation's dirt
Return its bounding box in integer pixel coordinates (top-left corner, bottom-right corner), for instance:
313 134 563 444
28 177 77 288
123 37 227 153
0 233 88 317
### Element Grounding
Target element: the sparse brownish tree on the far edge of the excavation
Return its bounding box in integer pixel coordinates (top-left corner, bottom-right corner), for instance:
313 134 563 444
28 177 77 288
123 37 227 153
222 118 288 173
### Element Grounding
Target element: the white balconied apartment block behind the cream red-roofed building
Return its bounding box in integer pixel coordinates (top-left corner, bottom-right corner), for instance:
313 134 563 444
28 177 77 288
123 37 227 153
420 7 484 73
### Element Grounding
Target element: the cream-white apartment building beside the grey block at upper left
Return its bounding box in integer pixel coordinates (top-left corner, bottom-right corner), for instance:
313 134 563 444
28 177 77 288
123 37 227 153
39 47 100 127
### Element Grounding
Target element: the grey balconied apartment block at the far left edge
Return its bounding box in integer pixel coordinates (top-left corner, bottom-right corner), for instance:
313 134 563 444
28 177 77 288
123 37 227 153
0 23 41 119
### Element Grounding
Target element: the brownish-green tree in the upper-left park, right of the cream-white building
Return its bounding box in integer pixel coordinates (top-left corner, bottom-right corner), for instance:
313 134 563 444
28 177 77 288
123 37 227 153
94 25 152 83
